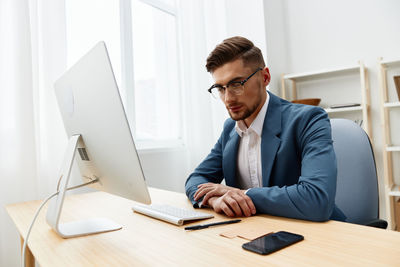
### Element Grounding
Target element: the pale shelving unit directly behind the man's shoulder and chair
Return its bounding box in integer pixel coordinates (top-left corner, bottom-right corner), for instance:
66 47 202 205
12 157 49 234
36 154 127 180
281 61 372 140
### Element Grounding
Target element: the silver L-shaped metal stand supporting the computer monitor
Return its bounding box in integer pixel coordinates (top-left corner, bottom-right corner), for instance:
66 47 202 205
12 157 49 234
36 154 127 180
46 135 122 238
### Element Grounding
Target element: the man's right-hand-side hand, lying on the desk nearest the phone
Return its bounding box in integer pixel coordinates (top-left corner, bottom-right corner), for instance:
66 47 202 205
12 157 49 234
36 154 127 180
208 191 256 217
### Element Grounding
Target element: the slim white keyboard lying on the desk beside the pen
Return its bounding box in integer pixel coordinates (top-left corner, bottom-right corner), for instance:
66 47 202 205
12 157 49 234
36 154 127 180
132 204 214 225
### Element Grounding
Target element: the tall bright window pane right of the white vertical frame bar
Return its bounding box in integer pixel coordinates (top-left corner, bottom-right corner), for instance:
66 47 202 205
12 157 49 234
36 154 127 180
132 0 180 140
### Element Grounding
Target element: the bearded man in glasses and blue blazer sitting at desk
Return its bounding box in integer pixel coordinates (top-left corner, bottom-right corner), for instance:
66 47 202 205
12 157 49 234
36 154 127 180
185 37 345 221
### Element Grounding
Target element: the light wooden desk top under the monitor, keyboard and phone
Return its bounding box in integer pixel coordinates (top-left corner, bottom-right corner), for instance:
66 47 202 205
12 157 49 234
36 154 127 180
7 189 400 267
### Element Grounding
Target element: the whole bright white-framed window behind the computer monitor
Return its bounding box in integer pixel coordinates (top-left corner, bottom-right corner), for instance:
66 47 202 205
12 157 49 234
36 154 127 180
66 0 182 148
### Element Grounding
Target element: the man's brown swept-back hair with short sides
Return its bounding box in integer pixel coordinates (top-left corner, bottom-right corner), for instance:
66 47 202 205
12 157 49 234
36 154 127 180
206 36 265 73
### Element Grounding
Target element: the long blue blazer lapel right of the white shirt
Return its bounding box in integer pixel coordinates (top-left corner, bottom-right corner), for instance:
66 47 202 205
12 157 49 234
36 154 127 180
261 92 282 187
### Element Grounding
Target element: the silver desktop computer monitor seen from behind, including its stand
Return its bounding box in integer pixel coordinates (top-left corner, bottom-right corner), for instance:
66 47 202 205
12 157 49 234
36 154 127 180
46 42 151 238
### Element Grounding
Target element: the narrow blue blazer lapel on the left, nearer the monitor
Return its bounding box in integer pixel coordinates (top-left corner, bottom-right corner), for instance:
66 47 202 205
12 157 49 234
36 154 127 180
222 128 239 187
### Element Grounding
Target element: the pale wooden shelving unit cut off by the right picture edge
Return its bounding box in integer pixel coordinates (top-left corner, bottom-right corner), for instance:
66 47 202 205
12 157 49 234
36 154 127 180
378 58 400 230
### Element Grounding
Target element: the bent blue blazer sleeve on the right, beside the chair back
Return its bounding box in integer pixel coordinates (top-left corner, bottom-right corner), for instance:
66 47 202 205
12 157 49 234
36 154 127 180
247 109 337 221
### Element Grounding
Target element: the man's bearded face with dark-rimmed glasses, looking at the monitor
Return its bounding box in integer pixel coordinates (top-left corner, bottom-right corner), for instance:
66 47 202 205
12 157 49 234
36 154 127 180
212 59 270 126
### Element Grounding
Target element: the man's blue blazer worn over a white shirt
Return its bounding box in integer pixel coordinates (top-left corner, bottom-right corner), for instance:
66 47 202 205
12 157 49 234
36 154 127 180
185 92 346 221
